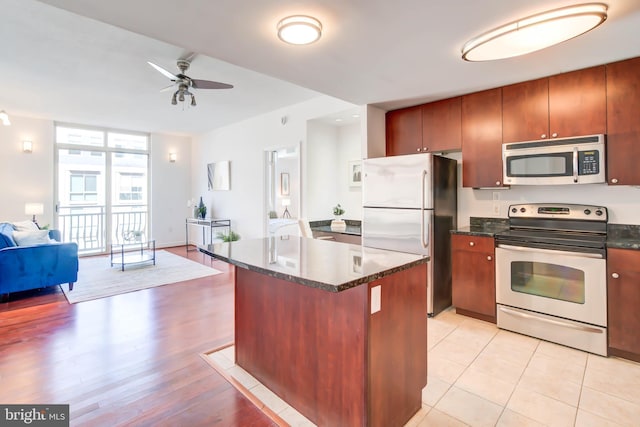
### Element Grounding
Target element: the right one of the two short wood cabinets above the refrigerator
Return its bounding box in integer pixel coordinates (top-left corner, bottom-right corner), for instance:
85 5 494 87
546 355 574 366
422 97 462 152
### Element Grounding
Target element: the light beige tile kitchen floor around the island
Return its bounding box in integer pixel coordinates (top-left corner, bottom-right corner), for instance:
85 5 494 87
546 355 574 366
208 310 640 427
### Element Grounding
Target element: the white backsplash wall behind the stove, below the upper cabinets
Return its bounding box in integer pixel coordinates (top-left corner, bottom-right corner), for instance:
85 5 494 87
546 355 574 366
447 153 640 227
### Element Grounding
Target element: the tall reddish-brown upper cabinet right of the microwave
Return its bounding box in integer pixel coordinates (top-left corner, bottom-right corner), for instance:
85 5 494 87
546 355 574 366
606 58 640 185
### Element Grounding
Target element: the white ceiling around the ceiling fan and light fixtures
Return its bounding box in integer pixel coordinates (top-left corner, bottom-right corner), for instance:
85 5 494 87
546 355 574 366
0 0 640 134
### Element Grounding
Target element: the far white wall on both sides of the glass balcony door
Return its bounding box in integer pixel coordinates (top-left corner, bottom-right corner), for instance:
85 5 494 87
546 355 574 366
0 115 192 247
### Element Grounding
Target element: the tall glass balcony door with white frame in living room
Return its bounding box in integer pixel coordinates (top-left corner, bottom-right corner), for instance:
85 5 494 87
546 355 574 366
55 124 150 254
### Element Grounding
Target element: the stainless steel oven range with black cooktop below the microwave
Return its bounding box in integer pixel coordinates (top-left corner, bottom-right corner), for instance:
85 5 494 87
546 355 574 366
496 203 607 356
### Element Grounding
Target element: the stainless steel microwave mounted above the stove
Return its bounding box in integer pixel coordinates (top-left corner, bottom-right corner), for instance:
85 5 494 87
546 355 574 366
502 135 606 185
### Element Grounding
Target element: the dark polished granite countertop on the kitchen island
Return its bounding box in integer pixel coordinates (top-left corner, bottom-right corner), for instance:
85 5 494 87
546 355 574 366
199 236 429 292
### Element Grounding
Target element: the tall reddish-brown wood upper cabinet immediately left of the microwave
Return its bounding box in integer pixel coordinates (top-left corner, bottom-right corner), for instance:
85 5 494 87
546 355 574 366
462 88 502 188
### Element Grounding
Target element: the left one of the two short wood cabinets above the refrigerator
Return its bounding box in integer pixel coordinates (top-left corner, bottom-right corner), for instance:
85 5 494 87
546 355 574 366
385 105 422 156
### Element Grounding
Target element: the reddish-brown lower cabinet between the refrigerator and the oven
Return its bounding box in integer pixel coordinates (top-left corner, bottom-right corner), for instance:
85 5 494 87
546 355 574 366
451 234 496 323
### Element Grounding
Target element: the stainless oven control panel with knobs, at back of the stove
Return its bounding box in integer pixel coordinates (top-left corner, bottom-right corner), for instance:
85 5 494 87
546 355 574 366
509 203 607 221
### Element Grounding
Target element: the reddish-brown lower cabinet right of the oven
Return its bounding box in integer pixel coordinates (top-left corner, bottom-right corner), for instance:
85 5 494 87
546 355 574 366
607 248 640 362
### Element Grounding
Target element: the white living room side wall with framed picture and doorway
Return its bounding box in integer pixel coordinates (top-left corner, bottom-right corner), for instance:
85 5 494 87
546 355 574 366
190 96 354 239
